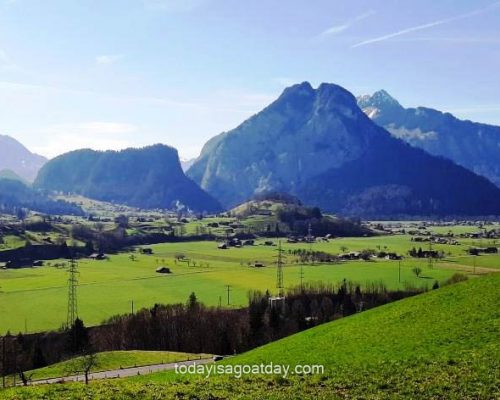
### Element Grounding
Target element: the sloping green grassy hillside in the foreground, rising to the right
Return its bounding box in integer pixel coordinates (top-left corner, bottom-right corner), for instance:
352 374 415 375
0 274 500 399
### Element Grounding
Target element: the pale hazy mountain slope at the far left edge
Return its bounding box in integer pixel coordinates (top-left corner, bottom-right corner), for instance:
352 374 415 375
0 135 47 182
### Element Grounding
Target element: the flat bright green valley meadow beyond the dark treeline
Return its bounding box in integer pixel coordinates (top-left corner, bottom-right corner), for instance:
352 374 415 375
0 235 500 333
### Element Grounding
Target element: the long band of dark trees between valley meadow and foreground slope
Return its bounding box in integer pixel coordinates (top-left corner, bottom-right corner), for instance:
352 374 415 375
0 281 423 379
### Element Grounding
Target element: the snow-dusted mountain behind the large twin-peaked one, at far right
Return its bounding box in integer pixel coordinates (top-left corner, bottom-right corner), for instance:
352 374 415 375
357 90 500 187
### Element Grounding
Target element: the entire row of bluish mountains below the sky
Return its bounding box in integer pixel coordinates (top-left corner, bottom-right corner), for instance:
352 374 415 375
0 82 500 218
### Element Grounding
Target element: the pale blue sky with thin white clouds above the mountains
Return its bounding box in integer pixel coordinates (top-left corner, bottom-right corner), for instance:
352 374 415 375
0 0 500 158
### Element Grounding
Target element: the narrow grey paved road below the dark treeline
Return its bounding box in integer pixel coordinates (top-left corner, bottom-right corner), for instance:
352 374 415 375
30 358 213 385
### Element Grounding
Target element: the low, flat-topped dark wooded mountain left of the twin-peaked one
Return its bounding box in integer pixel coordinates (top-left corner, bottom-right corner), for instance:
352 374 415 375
34 145 220 211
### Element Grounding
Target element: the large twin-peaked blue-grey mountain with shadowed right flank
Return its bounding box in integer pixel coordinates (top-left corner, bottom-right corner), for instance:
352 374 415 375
188 82 500 216
